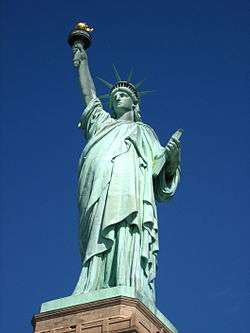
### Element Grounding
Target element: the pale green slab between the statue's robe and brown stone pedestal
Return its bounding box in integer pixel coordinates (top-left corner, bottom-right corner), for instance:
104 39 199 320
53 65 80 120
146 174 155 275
41 287 177 333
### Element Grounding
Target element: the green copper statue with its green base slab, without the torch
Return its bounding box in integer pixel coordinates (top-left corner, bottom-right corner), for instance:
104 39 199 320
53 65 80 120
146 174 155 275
46 32 182 329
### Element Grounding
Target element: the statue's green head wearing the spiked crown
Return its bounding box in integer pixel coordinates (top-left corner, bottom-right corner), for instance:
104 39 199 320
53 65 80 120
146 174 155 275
98 65 152 121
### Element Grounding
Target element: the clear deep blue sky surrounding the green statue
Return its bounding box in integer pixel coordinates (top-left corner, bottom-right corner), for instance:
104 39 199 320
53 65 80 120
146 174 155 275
0 0 250 333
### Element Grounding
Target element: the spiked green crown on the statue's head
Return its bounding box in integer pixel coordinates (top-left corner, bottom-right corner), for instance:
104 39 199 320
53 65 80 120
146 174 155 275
97 65 152 106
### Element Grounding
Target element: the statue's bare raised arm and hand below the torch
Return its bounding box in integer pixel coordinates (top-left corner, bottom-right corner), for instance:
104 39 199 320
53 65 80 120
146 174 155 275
72 41 96 105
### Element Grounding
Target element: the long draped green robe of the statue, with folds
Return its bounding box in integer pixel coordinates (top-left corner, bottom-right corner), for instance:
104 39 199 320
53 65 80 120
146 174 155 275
74 98 179 301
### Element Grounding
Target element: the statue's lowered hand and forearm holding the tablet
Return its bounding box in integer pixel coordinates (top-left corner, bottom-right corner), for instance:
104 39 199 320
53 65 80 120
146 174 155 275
165 136 181 178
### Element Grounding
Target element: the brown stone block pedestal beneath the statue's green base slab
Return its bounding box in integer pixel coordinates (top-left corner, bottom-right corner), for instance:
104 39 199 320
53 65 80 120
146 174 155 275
32 296 177 333
